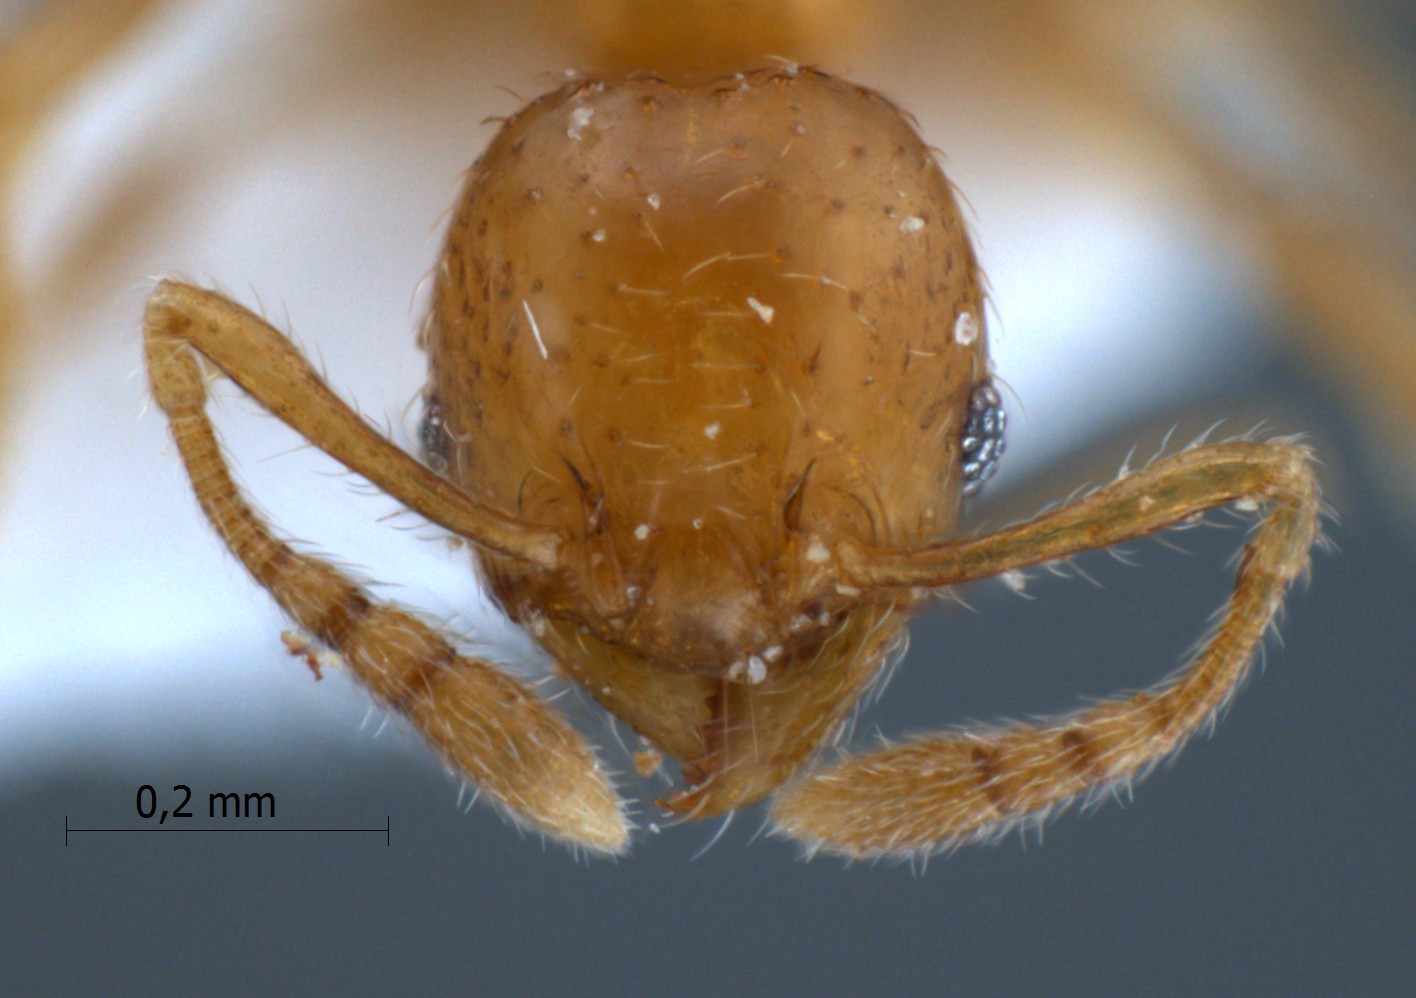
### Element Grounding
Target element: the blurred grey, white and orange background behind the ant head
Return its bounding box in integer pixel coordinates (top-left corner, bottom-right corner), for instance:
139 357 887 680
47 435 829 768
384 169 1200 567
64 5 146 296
0 0 1416 994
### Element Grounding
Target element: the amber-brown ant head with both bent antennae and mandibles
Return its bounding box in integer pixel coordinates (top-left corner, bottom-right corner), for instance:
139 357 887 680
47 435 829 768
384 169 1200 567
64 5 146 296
144 68 1321 858
